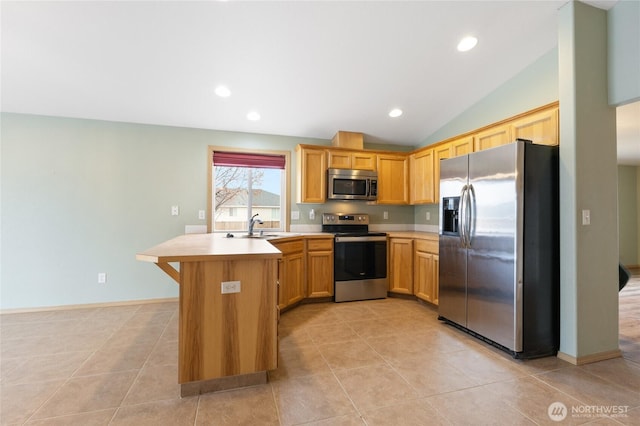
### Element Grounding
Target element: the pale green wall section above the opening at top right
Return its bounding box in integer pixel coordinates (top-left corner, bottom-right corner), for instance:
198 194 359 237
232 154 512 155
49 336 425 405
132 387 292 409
607 0 640 105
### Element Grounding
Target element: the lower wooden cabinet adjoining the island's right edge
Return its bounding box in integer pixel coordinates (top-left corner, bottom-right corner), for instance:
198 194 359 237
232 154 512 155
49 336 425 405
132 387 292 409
272 239 306 309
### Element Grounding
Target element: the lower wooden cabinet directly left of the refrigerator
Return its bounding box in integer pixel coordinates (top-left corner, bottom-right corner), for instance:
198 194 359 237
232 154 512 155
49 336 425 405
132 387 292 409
413 240 440 305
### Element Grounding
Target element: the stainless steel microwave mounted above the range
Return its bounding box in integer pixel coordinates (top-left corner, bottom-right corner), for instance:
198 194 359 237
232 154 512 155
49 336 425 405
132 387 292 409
327 169 378 200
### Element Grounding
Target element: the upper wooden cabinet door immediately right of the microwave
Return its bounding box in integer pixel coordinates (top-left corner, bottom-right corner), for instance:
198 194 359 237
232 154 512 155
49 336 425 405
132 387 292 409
377 154 409 204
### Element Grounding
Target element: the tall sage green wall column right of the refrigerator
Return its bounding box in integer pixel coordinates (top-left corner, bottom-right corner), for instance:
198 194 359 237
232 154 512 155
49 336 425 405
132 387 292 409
558 2 618 359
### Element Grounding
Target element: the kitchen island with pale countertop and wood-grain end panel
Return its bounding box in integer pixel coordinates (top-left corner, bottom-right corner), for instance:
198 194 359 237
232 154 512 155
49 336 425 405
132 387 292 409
136 234 282 396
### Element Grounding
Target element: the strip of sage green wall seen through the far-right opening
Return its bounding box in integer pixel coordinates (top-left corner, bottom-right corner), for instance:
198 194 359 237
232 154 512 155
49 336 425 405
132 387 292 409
618 166 640 266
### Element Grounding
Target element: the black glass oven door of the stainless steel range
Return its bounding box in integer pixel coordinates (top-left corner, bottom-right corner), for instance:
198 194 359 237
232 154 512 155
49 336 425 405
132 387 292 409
334 241 387 281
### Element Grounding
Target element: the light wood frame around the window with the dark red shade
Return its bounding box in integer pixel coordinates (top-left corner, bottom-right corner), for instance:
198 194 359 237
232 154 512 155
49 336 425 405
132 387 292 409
207 145 291 233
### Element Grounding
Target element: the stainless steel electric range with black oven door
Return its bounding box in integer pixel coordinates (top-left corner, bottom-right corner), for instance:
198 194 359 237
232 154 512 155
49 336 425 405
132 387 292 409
322 213 389 302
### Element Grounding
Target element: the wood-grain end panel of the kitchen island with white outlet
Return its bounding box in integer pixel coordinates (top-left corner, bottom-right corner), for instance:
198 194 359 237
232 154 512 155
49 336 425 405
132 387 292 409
178 258 278 383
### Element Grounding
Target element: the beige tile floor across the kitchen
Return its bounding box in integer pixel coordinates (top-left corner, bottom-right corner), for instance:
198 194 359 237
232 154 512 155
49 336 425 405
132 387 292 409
0 277 640 426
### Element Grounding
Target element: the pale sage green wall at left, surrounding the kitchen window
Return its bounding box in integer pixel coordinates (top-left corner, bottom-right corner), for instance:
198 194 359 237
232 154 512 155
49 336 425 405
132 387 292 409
0 113 328 310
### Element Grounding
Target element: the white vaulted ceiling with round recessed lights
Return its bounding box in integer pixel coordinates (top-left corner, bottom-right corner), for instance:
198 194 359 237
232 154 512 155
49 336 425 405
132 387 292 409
1 0 640 164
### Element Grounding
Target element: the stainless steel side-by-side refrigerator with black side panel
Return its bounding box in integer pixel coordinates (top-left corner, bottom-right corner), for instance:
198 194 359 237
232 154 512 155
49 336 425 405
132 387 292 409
438 140 560 358
